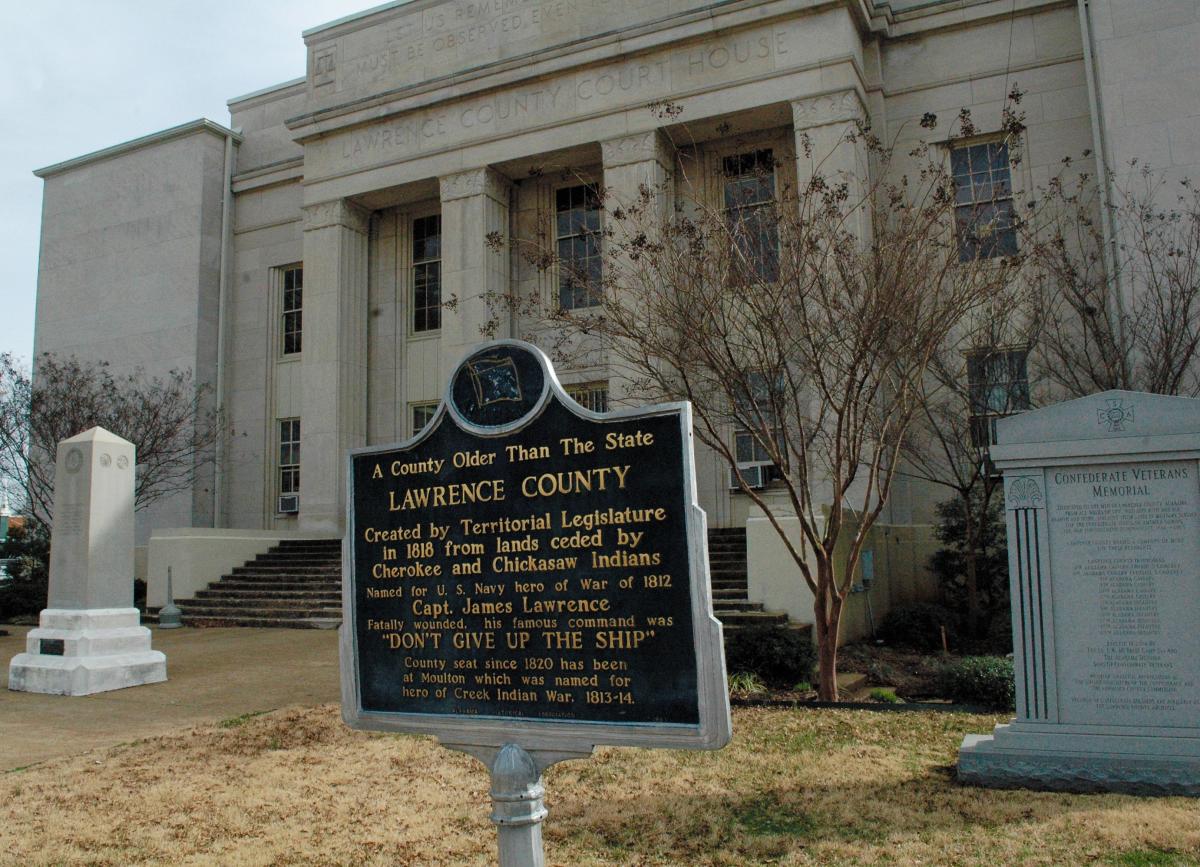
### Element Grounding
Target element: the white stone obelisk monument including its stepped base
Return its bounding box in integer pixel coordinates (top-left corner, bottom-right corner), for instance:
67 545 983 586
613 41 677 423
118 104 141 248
8 427 167 695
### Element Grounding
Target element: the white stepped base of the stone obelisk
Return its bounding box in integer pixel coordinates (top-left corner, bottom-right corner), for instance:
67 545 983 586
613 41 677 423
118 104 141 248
8 608 167 695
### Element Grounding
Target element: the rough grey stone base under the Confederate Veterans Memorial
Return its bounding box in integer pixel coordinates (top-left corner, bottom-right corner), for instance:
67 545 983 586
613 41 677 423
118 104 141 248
958 723 1200 796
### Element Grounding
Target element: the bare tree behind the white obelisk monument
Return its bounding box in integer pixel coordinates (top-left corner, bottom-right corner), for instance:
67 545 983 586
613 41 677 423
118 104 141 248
0 353 218 526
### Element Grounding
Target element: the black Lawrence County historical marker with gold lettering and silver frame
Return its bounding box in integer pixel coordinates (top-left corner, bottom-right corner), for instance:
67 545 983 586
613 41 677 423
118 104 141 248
342 341 730 766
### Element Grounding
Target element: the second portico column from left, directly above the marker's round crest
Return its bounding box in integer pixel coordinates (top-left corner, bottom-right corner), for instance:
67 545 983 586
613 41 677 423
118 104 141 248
439 167 514 384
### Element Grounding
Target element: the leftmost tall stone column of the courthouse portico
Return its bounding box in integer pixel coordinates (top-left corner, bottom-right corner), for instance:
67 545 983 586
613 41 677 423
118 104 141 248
300 199 370 531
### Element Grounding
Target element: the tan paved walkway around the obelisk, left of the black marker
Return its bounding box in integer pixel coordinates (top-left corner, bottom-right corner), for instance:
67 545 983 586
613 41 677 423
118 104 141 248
0 626 340 772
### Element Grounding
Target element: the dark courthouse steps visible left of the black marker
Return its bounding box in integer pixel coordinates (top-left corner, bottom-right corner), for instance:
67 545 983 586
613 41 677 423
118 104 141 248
148 539 342 629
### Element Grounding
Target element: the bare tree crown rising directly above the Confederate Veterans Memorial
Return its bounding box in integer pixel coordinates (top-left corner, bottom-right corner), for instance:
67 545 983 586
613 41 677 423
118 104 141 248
1028 161 1200 396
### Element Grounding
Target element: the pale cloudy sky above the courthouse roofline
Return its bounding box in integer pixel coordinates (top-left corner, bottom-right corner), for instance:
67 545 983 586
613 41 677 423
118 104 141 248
0 0 382 360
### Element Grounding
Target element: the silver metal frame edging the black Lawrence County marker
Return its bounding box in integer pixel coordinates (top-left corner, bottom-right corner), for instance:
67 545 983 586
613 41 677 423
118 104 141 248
338 339 732 758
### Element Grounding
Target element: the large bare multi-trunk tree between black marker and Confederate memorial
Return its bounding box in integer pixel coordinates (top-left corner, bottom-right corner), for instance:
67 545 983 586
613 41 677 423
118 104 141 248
492 115 1019 700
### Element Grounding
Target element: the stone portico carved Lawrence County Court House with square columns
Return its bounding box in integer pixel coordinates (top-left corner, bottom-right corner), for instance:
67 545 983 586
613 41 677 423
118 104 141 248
274 2 869 530
